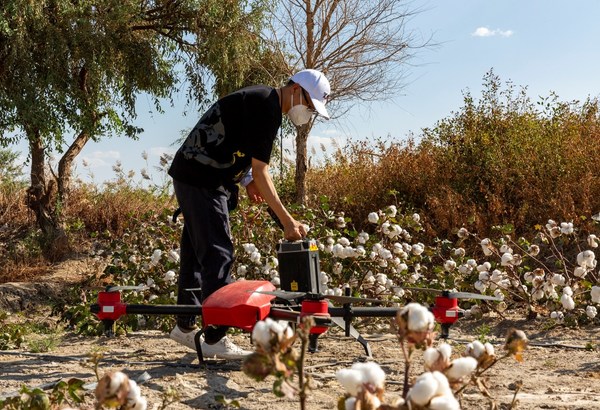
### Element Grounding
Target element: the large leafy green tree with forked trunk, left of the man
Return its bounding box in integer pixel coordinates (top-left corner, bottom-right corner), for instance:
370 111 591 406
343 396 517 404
0 0 284 256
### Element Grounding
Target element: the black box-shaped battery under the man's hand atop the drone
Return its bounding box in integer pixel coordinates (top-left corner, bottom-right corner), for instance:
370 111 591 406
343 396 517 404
277 240 321 293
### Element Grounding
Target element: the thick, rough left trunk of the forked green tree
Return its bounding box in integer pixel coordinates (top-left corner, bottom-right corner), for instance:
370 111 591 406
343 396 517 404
27 131 69 260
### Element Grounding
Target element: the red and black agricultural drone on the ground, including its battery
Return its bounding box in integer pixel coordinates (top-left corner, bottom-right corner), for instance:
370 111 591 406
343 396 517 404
91 240 501 363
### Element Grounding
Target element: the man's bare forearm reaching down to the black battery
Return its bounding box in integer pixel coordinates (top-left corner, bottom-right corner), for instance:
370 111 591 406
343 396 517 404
252 158 306 241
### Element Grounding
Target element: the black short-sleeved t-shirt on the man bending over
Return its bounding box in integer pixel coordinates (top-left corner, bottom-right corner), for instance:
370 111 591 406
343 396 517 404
169 86 282 188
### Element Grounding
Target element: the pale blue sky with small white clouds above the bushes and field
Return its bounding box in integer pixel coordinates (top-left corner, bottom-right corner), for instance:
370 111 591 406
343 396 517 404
14 0 600 186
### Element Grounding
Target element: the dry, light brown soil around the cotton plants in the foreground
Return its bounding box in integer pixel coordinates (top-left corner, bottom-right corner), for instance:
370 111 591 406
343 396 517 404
0 262 600 410
